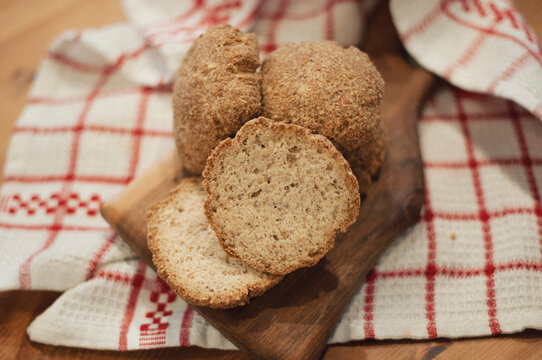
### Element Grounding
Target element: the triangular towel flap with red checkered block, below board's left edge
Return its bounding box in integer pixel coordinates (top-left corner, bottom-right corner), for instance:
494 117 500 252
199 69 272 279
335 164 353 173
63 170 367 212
28 259 224 350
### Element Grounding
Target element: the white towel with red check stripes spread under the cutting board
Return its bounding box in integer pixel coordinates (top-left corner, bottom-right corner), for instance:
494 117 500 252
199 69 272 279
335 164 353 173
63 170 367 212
0 0 542 350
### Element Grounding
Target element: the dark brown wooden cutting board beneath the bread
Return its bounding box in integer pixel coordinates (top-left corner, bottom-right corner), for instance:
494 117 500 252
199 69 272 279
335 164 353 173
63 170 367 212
102 4 434 359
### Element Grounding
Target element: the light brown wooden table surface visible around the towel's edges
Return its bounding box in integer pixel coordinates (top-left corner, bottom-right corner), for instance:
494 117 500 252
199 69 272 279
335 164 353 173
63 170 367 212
0 0 542 360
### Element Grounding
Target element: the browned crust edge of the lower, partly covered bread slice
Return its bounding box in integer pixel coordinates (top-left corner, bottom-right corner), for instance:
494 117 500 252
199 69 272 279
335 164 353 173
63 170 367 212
146 177 282 309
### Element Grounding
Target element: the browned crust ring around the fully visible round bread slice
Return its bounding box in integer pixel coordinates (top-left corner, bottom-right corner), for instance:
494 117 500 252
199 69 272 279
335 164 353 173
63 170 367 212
203 117 360 275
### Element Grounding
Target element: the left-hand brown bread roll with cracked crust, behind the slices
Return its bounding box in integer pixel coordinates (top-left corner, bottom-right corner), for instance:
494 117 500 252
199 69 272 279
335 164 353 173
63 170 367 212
173 25 261 174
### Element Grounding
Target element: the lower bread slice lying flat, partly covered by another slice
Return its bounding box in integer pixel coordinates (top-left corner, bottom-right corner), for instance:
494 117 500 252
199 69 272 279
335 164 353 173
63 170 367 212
147 178 282 309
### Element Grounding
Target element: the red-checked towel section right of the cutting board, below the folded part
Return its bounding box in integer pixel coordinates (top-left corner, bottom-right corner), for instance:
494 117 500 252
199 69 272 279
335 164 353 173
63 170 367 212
333 86 542 342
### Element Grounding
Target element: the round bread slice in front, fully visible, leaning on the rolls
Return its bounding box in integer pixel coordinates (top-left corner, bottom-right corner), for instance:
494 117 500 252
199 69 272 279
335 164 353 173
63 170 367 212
203 117 360 274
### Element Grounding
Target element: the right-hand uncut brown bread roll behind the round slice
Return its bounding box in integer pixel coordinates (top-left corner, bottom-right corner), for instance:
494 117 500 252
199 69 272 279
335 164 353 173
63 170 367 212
262 41 385 185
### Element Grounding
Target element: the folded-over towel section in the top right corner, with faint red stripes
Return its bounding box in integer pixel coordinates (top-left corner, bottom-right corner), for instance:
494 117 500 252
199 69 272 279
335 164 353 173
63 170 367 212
391 0 542 118
